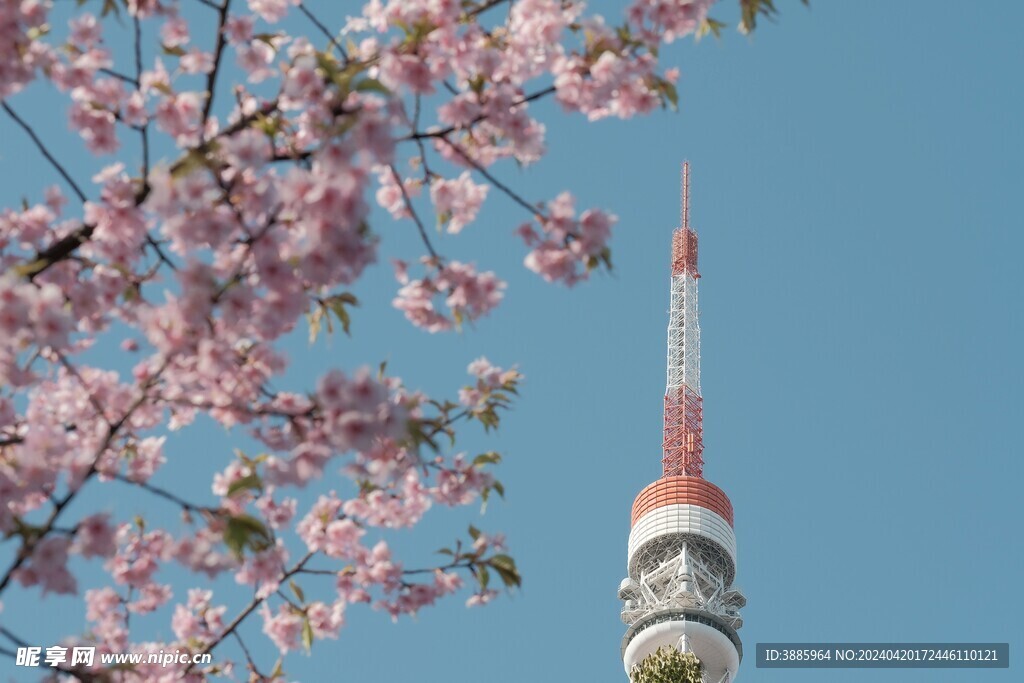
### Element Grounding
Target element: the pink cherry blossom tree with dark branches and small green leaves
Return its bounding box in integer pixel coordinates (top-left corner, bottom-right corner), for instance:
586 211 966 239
0 0 794 681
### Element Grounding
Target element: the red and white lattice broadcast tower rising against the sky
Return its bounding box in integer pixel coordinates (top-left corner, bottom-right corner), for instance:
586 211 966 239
618 163 746 683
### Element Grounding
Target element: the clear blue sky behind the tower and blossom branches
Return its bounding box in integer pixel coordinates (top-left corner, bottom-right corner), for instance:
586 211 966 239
0 0 1024 683
